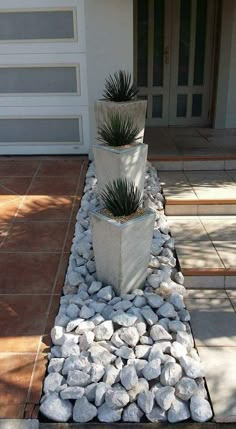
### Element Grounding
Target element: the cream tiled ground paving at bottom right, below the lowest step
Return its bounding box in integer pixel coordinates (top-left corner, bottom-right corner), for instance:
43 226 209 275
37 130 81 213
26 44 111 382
186 290 236 427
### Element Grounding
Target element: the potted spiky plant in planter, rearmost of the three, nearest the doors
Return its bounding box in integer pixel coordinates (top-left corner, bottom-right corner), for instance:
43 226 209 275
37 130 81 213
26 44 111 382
95 70 147 143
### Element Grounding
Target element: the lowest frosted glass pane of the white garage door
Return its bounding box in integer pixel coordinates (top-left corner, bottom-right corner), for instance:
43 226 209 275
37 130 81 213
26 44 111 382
0 118 80 143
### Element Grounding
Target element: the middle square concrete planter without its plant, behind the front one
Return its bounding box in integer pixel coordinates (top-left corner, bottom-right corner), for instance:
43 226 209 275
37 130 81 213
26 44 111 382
93 143 148 194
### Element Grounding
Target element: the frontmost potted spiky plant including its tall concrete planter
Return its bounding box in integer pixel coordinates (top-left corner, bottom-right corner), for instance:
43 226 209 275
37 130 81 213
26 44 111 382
90 178 155 295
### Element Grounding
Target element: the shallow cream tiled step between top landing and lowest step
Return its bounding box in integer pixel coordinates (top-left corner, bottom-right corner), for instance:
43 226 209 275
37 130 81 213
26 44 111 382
159 170 236 216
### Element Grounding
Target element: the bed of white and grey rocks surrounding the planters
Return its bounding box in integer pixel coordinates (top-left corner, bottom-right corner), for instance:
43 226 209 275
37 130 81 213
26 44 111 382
40 163 212 423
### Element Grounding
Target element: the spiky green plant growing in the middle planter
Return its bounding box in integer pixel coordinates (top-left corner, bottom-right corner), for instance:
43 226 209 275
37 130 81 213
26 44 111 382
98 112 139 146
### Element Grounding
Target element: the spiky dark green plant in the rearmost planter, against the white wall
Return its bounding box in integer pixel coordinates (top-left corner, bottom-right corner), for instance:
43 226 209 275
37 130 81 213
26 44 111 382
103 70 138 102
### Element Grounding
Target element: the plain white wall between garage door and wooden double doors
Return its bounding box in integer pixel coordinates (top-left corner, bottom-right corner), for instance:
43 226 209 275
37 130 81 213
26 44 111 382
85 0 133 157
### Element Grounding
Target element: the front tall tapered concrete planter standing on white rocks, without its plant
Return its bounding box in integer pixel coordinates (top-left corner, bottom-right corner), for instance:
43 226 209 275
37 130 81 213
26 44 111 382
90 209 155 295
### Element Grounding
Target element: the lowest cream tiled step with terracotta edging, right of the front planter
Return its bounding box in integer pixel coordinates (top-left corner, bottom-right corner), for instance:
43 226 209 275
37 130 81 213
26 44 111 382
168 216 236 289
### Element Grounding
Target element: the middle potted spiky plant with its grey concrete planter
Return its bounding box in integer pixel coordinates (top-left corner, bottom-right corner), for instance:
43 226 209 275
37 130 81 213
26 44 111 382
93 112 148 195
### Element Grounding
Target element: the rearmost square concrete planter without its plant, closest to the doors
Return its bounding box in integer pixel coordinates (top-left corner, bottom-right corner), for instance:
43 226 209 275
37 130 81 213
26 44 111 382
95 100 147 143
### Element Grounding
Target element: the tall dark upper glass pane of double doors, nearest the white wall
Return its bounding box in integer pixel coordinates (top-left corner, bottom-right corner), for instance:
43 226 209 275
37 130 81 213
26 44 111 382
153 0 165 86
